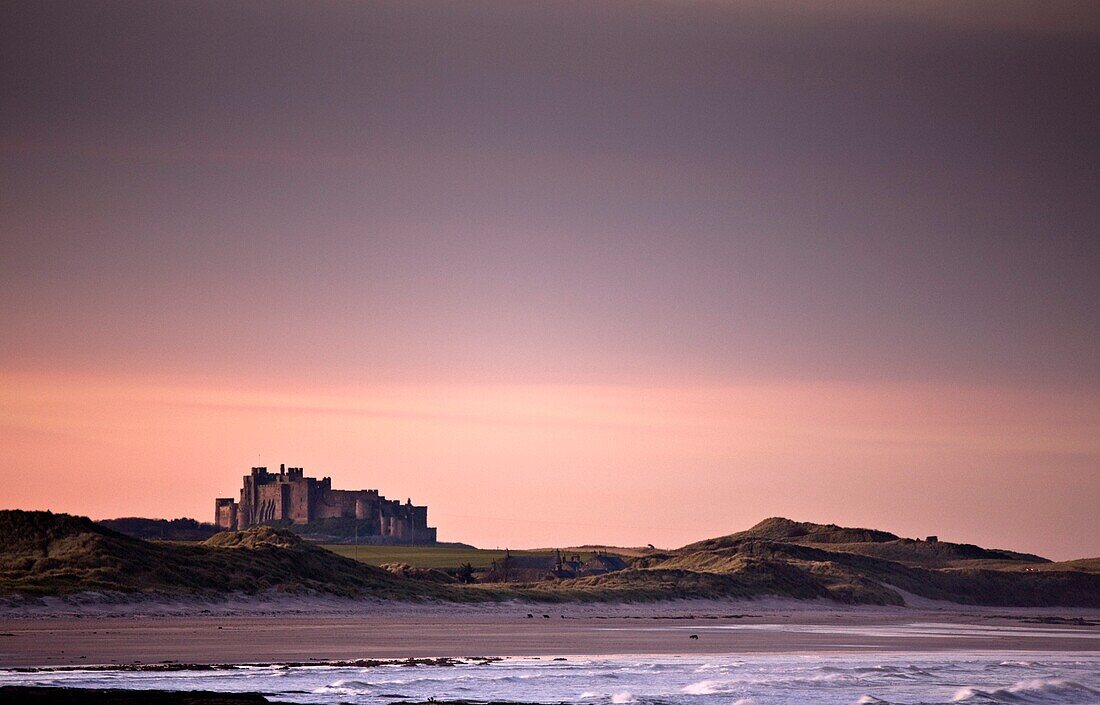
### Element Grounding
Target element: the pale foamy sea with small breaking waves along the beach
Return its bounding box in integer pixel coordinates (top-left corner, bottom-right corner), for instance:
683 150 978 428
0 625 1100 705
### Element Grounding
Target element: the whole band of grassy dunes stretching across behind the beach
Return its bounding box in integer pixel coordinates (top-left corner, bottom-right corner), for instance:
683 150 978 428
0 510 1100 607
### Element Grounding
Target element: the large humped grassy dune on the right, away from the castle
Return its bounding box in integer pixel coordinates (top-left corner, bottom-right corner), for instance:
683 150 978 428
623 518 1100 607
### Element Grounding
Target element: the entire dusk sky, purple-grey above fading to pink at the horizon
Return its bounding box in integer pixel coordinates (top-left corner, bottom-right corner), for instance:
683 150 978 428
0 0 1100 558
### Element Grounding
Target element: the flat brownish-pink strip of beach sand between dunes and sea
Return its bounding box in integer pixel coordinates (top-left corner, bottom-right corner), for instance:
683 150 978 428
0 603 1100 668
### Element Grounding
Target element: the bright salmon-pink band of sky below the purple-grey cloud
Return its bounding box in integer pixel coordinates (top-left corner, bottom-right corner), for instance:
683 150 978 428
0 375 1100 558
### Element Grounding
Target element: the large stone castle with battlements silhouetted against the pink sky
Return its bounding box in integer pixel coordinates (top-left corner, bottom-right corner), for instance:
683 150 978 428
215 465 436 543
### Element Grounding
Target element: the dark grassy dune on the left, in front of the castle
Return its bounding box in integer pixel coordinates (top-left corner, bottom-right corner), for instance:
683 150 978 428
0 510 446 598
